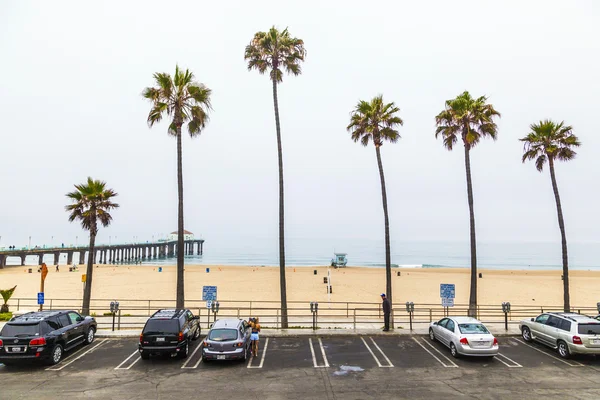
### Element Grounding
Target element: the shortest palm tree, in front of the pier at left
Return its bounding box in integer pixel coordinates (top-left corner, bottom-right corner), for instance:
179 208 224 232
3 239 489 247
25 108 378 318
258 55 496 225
65 178 119 315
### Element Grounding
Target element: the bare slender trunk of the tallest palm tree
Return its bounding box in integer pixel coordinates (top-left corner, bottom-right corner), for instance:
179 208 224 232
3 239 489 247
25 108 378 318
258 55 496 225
272 79 288 329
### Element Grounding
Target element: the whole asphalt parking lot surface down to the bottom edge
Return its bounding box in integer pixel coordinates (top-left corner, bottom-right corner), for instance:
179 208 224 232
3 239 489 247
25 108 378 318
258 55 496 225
0 335 600 399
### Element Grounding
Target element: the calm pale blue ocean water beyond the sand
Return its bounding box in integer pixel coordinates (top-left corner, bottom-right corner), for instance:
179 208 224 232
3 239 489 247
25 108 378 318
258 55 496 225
7 237 600 271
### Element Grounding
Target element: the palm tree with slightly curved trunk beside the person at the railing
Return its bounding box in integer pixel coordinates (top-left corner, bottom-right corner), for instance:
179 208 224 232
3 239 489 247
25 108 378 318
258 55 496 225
346 95 403 318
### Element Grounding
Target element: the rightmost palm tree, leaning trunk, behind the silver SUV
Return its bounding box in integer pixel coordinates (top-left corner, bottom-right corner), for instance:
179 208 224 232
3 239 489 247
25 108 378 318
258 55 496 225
519 119 581 312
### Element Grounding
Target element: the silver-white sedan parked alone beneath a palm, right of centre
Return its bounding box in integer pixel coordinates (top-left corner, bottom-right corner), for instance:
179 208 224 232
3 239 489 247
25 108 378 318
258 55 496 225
429 317 498 357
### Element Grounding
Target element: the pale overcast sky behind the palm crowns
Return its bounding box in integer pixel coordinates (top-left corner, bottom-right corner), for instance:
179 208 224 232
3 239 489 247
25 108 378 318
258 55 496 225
0 0 600 250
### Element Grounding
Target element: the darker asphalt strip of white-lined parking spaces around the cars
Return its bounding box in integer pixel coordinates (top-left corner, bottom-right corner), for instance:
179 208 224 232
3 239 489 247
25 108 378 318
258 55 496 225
0 336 600 376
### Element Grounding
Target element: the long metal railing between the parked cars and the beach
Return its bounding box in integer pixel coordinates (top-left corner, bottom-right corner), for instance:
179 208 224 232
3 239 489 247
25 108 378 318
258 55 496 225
9 298 598 330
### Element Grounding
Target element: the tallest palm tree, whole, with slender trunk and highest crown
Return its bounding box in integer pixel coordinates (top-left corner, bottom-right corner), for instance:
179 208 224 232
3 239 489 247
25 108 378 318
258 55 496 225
244 27 306 328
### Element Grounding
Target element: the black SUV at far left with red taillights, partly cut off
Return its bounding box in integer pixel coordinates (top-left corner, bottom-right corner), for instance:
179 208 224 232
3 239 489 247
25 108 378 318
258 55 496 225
0 310 97 365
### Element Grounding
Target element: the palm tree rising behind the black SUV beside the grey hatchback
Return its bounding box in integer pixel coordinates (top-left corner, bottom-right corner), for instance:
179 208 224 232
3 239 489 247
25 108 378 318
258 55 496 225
142 66 211 308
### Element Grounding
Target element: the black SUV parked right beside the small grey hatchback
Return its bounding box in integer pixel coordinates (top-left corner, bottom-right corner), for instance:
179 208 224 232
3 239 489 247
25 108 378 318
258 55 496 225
139 309 201 360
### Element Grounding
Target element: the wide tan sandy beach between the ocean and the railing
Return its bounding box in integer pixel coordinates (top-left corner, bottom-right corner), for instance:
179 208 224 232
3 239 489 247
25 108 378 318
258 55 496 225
0 265 600 307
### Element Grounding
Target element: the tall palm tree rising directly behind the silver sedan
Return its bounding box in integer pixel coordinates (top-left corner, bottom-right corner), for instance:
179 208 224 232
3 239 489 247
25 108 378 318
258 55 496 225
435 91 500 317
